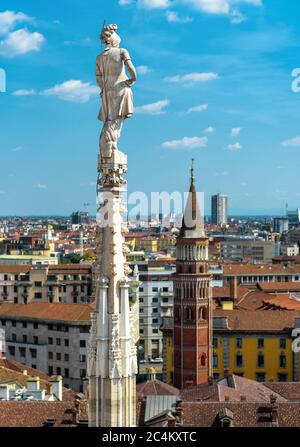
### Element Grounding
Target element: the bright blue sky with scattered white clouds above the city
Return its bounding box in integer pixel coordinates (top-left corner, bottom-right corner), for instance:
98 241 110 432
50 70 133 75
0 0 300 215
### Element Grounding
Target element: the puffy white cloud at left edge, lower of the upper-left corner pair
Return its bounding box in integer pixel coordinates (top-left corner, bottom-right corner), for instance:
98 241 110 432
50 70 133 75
0 28 45 57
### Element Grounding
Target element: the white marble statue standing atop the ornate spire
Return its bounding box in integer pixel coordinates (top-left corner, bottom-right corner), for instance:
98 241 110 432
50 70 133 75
96 24 136 162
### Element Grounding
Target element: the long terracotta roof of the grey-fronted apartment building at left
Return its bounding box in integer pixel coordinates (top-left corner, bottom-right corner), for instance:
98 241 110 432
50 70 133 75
0 303 94 323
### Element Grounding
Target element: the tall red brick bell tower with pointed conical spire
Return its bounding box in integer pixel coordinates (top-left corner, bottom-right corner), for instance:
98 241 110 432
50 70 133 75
173 160 212 389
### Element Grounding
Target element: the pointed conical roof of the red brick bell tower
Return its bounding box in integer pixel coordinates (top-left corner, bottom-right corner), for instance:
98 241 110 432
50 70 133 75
180 159 205 238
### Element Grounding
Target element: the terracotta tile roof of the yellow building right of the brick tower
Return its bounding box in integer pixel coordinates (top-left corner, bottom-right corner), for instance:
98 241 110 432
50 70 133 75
214 309 300 332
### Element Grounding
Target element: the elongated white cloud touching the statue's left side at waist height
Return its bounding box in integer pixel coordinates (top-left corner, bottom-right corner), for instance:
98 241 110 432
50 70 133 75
42 80 99 103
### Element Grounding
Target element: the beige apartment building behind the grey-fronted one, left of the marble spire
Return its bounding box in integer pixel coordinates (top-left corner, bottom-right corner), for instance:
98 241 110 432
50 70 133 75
0 264 93 304
